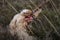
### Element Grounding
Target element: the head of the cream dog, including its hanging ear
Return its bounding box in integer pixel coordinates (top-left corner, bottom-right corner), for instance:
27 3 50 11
9 9 33 34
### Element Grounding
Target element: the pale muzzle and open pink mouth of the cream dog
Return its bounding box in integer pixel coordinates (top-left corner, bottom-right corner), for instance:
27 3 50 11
20 9 33 22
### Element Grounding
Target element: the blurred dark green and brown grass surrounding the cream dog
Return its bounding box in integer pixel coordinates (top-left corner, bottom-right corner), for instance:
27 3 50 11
0 0 60 40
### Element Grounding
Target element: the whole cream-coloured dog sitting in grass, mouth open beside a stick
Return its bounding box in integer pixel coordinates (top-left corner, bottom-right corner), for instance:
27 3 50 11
9 9 41 40
